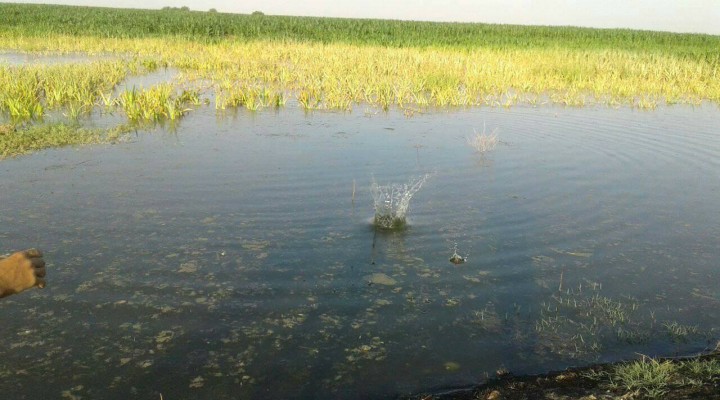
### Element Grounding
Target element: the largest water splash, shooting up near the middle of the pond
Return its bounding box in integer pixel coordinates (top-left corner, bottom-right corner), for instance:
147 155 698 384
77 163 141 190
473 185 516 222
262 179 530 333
370 174 430 229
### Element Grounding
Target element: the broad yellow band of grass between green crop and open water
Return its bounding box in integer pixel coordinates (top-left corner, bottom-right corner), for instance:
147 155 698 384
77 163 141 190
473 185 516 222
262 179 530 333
0 35 720 110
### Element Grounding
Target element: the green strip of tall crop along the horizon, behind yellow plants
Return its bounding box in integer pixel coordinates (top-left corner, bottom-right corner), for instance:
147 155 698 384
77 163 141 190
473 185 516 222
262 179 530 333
0 4 720 59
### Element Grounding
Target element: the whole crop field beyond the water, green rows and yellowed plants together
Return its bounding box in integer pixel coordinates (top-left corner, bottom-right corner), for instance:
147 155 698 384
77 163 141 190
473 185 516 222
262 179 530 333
0 4 720 155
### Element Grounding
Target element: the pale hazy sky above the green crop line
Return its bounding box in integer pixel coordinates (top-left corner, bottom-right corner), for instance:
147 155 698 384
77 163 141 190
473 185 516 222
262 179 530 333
5 0 720 35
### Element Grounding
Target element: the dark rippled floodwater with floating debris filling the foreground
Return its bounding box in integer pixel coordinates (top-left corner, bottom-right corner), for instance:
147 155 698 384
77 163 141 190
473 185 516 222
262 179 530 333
0 106 720 399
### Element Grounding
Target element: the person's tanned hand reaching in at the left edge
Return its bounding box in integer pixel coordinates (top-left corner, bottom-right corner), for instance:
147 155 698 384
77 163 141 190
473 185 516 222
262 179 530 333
0 249 45 298
